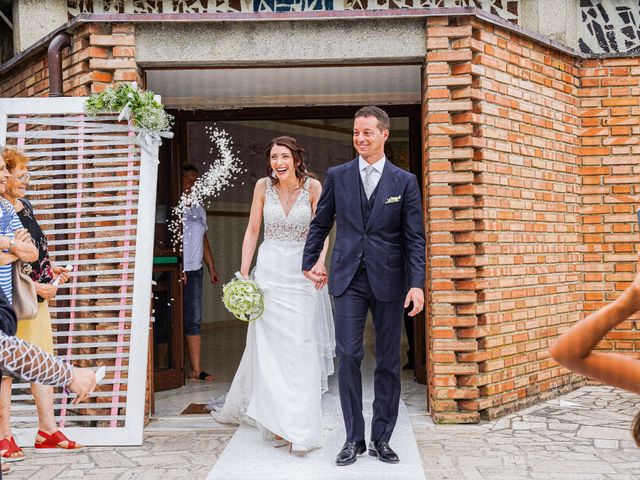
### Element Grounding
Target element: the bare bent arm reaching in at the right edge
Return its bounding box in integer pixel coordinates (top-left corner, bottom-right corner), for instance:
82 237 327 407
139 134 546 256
549 266 640 393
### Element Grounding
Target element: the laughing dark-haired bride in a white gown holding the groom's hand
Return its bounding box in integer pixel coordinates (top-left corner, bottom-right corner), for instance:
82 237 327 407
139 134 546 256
212 137 335 454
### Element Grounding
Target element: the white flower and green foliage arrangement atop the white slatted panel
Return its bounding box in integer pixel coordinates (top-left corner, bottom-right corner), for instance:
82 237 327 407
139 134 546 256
85 83 173 133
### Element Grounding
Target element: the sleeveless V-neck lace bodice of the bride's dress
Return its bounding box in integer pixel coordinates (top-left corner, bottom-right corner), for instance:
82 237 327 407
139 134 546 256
263 178 312 242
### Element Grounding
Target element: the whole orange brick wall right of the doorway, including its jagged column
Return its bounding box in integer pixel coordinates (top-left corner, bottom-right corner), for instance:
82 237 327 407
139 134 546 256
423 18 640 422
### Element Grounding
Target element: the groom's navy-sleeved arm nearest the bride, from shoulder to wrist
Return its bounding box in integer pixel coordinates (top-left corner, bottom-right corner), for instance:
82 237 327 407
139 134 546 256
302 169 336 272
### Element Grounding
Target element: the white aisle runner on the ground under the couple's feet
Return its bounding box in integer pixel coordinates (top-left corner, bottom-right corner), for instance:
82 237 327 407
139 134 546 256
207 386 425 480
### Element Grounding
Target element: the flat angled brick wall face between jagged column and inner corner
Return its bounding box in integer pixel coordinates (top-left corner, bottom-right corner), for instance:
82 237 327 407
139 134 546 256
468 17 584 417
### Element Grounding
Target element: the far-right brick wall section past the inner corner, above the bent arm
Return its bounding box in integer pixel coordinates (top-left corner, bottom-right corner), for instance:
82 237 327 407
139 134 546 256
579 57 640 352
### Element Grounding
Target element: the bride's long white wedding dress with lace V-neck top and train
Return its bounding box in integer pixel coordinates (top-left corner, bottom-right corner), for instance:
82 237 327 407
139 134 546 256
212 179 335 449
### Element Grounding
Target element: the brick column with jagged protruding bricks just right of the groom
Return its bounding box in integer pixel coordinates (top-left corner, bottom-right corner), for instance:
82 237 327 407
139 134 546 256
423 18 482 423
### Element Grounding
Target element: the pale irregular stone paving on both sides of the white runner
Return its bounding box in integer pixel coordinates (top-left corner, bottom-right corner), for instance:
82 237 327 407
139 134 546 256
7 387 640 480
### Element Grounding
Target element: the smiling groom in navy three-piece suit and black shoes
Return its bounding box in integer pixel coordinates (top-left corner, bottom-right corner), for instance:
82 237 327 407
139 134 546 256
302 106 425 465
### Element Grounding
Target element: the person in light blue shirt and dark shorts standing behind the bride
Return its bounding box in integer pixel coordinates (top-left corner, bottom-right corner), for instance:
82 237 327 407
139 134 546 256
181 163 220 382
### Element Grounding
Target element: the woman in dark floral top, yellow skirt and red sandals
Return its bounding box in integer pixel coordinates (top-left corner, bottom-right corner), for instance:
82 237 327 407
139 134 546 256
0 148 82 461
